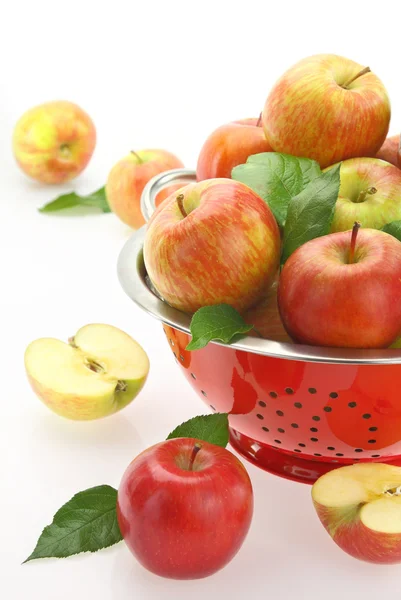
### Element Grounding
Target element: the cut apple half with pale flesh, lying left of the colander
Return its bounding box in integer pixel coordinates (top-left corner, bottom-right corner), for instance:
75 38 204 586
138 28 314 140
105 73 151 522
25 323 149 420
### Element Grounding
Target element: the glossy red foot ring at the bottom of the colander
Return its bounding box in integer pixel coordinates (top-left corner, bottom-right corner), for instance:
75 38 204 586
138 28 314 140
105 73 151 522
230 428 401 485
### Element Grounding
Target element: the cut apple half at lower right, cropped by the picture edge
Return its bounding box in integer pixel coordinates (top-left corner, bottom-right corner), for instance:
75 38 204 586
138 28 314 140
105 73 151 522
312 463 401 563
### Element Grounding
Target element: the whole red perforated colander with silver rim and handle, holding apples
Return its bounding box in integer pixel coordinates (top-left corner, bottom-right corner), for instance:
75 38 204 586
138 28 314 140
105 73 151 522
118 169 401 483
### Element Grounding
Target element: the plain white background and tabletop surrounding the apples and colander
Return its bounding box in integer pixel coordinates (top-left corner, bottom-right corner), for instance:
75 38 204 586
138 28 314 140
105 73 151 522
0 0 401 600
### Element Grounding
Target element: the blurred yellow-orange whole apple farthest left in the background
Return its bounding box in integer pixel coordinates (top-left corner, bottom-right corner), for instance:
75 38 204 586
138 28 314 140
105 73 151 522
12 101 96 184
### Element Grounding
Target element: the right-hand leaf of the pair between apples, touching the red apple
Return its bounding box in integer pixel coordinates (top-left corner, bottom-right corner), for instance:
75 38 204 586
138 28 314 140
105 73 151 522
281 164 341 263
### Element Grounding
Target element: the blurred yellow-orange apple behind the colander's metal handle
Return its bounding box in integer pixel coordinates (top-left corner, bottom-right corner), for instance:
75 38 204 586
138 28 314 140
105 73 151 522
106 149 184 229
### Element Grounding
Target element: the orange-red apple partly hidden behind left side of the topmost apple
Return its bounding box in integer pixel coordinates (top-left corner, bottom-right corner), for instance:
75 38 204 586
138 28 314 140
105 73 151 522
196 118 272 181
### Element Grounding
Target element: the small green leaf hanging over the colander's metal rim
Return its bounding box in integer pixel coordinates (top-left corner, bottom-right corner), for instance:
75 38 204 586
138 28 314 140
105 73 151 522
186 304 253 350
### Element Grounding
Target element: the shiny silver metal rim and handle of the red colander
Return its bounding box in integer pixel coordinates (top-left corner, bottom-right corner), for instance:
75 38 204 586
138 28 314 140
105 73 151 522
117 169 401 365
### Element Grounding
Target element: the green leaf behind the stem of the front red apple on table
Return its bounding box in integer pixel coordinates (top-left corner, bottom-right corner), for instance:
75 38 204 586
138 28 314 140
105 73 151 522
167 413 229 448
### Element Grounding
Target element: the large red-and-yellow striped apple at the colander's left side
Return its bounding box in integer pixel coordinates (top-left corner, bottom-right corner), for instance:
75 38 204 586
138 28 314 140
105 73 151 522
144 179 280 313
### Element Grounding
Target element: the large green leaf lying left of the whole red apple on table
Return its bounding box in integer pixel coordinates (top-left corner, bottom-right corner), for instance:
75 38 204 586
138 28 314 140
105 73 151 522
24 485 122 562
